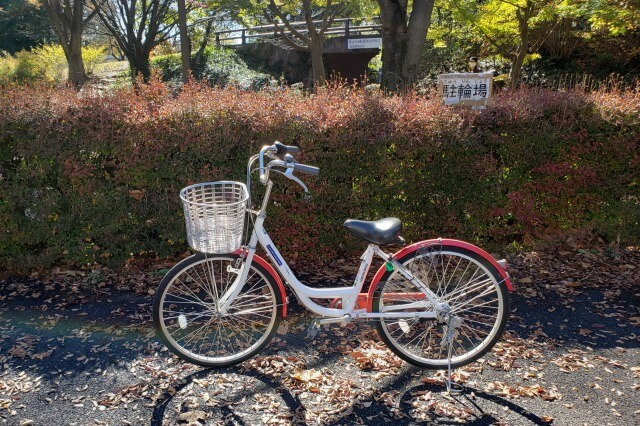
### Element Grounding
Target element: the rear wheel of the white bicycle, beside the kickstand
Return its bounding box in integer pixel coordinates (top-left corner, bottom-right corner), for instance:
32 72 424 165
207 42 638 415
372 245 509 369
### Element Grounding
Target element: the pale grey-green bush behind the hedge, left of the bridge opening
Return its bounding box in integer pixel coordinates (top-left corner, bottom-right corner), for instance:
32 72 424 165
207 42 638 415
151 48 274 89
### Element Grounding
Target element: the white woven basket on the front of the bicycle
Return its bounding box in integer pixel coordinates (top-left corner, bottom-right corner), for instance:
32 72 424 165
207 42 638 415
180 181 249 253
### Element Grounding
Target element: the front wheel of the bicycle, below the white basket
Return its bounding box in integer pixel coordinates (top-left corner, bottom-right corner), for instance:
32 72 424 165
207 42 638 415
153 253 283 368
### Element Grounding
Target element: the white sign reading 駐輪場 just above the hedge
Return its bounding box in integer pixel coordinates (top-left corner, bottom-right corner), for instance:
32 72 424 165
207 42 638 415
438 72 493 106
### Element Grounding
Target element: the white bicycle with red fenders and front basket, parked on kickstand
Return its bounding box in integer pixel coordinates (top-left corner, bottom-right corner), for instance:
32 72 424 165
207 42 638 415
153 142 513 390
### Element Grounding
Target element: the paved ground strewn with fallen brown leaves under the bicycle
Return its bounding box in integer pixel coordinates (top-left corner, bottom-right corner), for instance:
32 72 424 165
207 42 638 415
0 250 640 425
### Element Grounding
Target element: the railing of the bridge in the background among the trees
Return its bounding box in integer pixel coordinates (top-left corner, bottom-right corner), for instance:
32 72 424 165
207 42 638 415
215 18 382 46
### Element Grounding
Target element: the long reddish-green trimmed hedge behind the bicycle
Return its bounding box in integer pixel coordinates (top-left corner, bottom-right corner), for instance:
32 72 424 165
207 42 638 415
0 81 640 272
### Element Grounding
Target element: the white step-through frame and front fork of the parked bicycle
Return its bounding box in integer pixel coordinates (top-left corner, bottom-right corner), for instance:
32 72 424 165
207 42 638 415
219 180 443 319
